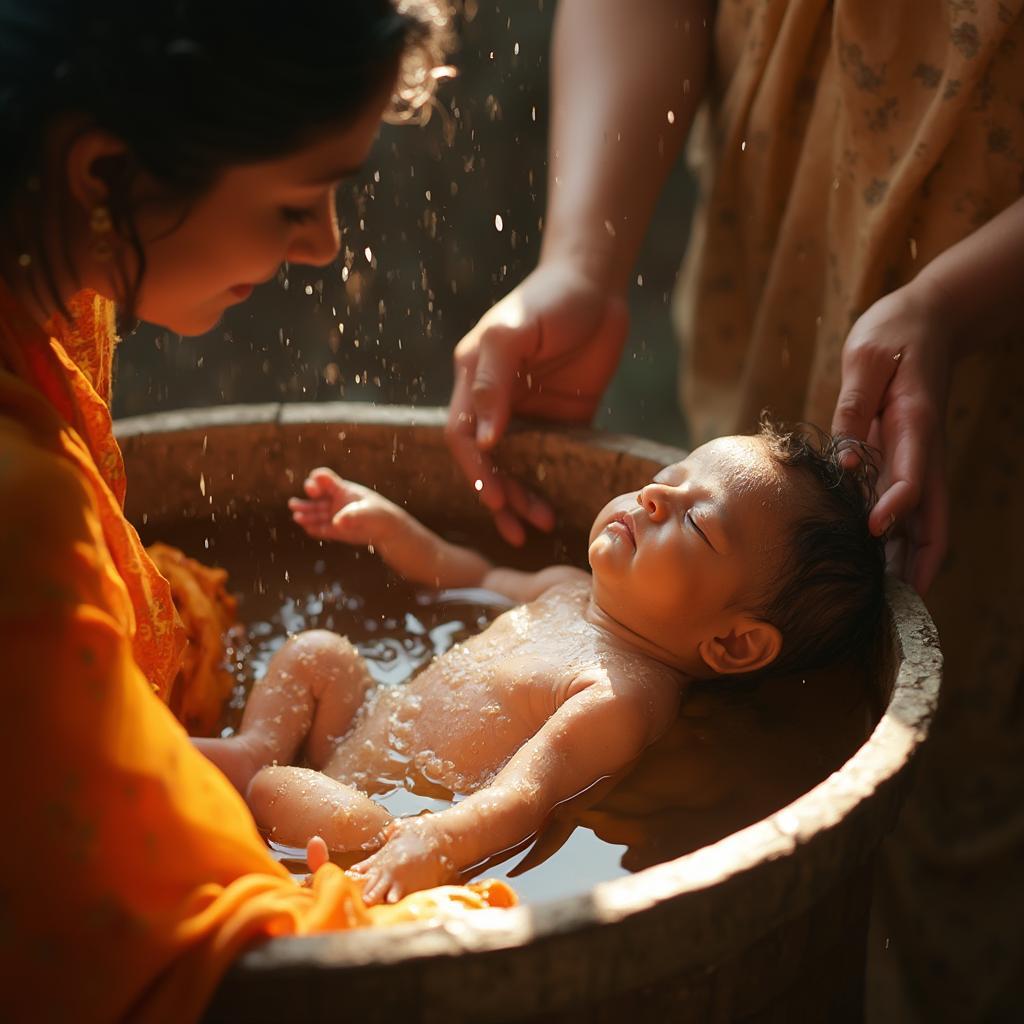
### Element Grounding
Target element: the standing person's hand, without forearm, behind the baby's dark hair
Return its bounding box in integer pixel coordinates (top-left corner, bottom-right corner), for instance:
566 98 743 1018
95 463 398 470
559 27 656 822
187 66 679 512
831 279 955 594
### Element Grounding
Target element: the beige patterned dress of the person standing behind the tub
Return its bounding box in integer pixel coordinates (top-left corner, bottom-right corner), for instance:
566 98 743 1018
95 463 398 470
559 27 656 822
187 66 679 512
676 0 1024 1021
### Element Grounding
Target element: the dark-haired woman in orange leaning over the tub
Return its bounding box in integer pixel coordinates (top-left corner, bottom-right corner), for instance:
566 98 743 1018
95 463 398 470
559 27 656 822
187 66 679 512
0 0 509 1021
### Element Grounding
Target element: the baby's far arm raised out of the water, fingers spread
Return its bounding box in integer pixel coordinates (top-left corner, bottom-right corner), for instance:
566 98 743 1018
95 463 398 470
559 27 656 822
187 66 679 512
288 467 586 601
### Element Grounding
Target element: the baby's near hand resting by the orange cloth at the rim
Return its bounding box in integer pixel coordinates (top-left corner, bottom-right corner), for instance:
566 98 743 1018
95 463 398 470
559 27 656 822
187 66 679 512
349 815 456 906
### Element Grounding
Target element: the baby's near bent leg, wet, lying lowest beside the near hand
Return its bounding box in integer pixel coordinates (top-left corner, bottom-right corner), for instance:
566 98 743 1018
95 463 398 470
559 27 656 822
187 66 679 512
248 767 391 852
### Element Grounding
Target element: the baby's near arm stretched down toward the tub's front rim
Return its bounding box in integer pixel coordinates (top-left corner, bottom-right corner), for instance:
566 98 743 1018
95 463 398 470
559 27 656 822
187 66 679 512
352 676 681 903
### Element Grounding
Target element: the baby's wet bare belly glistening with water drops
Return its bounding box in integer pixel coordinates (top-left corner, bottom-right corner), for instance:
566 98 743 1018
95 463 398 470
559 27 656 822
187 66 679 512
325 677 536 795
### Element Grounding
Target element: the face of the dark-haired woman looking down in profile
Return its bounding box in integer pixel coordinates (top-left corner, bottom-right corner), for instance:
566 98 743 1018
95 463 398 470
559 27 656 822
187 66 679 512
103 94 387 335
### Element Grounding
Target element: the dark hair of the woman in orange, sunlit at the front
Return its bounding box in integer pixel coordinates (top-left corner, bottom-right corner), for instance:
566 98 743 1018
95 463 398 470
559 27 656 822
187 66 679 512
0 0 447 314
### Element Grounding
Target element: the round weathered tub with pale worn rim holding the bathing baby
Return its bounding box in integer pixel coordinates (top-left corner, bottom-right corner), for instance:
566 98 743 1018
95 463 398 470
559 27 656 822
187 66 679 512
118 403 941 1022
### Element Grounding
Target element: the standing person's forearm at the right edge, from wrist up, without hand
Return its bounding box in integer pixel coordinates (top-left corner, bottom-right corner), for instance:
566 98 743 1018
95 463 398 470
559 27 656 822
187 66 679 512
909 193 1024 354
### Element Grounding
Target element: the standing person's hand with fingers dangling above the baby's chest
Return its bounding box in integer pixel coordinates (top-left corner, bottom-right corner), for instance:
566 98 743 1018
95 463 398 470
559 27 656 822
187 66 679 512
446 262 628 546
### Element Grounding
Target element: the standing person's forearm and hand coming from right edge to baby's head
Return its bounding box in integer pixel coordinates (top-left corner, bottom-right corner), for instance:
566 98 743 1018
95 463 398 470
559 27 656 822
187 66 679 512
833 193 1024 594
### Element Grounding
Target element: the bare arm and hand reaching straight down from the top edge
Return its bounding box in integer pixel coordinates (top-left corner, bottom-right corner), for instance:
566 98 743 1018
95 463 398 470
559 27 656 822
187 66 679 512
447 0 711 544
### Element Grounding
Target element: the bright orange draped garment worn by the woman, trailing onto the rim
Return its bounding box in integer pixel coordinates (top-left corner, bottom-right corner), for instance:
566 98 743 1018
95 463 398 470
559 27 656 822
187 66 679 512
0 286 514 1022
